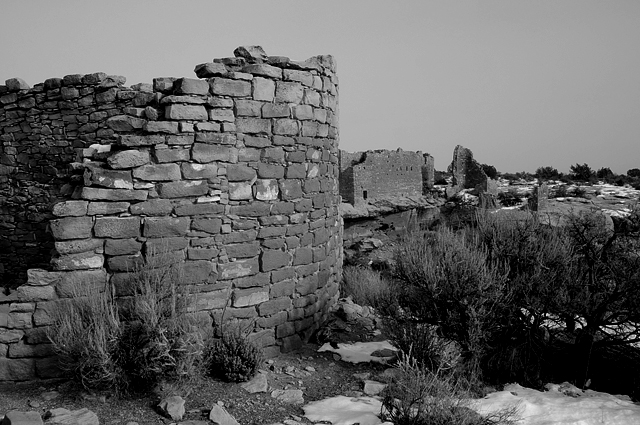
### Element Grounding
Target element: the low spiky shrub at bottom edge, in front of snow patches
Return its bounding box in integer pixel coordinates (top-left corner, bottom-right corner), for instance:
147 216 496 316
381 355 517 425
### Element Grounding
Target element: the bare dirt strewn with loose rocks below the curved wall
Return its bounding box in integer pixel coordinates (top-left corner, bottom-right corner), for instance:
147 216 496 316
0 300 396 425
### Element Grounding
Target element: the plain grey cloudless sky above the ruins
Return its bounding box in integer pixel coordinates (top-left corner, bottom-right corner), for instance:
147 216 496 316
0 0 640 173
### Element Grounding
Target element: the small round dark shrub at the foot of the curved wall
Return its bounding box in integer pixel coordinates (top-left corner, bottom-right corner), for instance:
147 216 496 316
206 326 264 382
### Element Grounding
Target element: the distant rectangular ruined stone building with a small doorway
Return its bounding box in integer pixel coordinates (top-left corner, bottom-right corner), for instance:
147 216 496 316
340 149 434 205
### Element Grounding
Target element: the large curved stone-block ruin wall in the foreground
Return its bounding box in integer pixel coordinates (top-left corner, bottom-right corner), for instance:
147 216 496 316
0 47 342 380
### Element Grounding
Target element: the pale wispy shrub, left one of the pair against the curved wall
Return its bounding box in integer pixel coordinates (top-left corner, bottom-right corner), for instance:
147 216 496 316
47 287 126 391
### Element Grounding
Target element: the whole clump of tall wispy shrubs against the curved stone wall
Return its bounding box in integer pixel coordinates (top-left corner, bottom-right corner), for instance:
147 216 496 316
49 247 206 393
